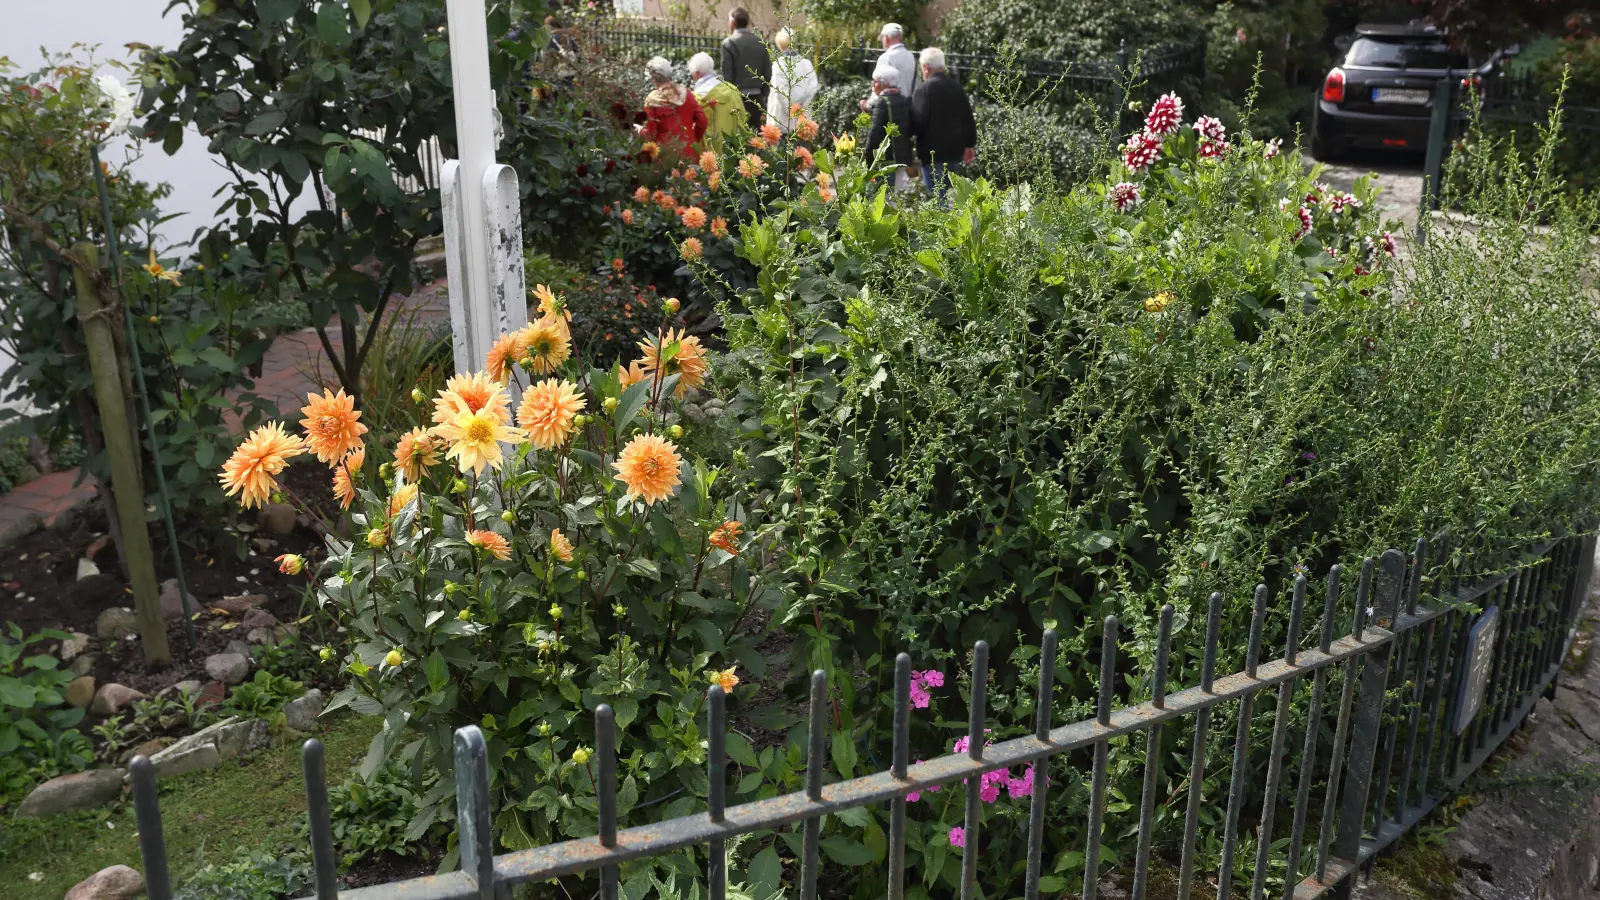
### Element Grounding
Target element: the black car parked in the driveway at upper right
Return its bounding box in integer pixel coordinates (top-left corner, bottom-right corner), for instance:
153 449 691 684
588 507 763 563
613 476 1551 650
1310 26 1498 160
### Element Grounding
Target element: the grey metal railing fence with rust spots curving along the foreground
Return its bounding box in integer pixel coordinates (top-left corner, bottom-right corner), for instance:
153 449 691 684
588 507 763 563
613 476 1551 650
130 538 1595 900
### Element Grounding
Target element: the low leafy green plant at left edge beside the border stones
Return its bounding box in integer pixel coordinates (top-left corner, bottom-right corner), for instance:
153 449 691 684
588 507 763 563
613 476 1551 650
0 623 94 806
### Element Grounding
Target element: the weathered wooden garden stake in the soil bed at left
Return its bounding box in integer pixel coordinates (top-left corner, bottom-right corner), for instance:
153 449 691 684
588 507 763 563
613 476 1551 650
72 243 173 669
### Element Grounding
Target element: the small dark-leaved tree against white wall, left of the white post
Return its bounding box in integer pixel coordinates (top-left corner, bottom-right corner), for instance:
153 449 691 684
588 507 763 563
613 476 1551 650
141 0 534 402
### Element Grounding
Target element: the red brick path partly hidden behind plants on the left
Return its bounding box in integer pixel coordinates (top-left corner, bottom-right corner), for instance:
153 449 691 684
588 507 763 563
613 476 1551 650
0 280 448 544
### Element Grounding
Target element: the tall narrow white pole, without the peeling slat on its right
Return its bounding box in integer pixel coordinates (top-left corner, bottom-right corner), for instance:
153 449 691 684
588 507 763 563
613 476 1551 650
445 0 496 370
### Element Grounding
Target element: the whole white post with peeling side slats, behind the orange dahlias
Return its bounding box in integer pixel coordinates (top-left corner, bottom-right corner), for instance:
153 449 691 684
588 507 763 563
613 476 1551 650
438 0 528 372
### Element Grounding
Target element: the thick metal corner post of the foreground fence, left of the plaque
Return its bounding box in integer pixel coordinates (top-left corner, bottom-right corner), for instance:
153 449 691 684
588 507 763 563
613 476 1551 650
1333 549 1405 900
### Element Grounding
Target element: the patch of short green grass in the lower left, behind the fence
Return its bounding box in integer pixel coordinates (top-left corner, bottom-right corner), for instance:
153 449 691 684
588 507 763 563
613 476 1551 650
0 716 382 900
